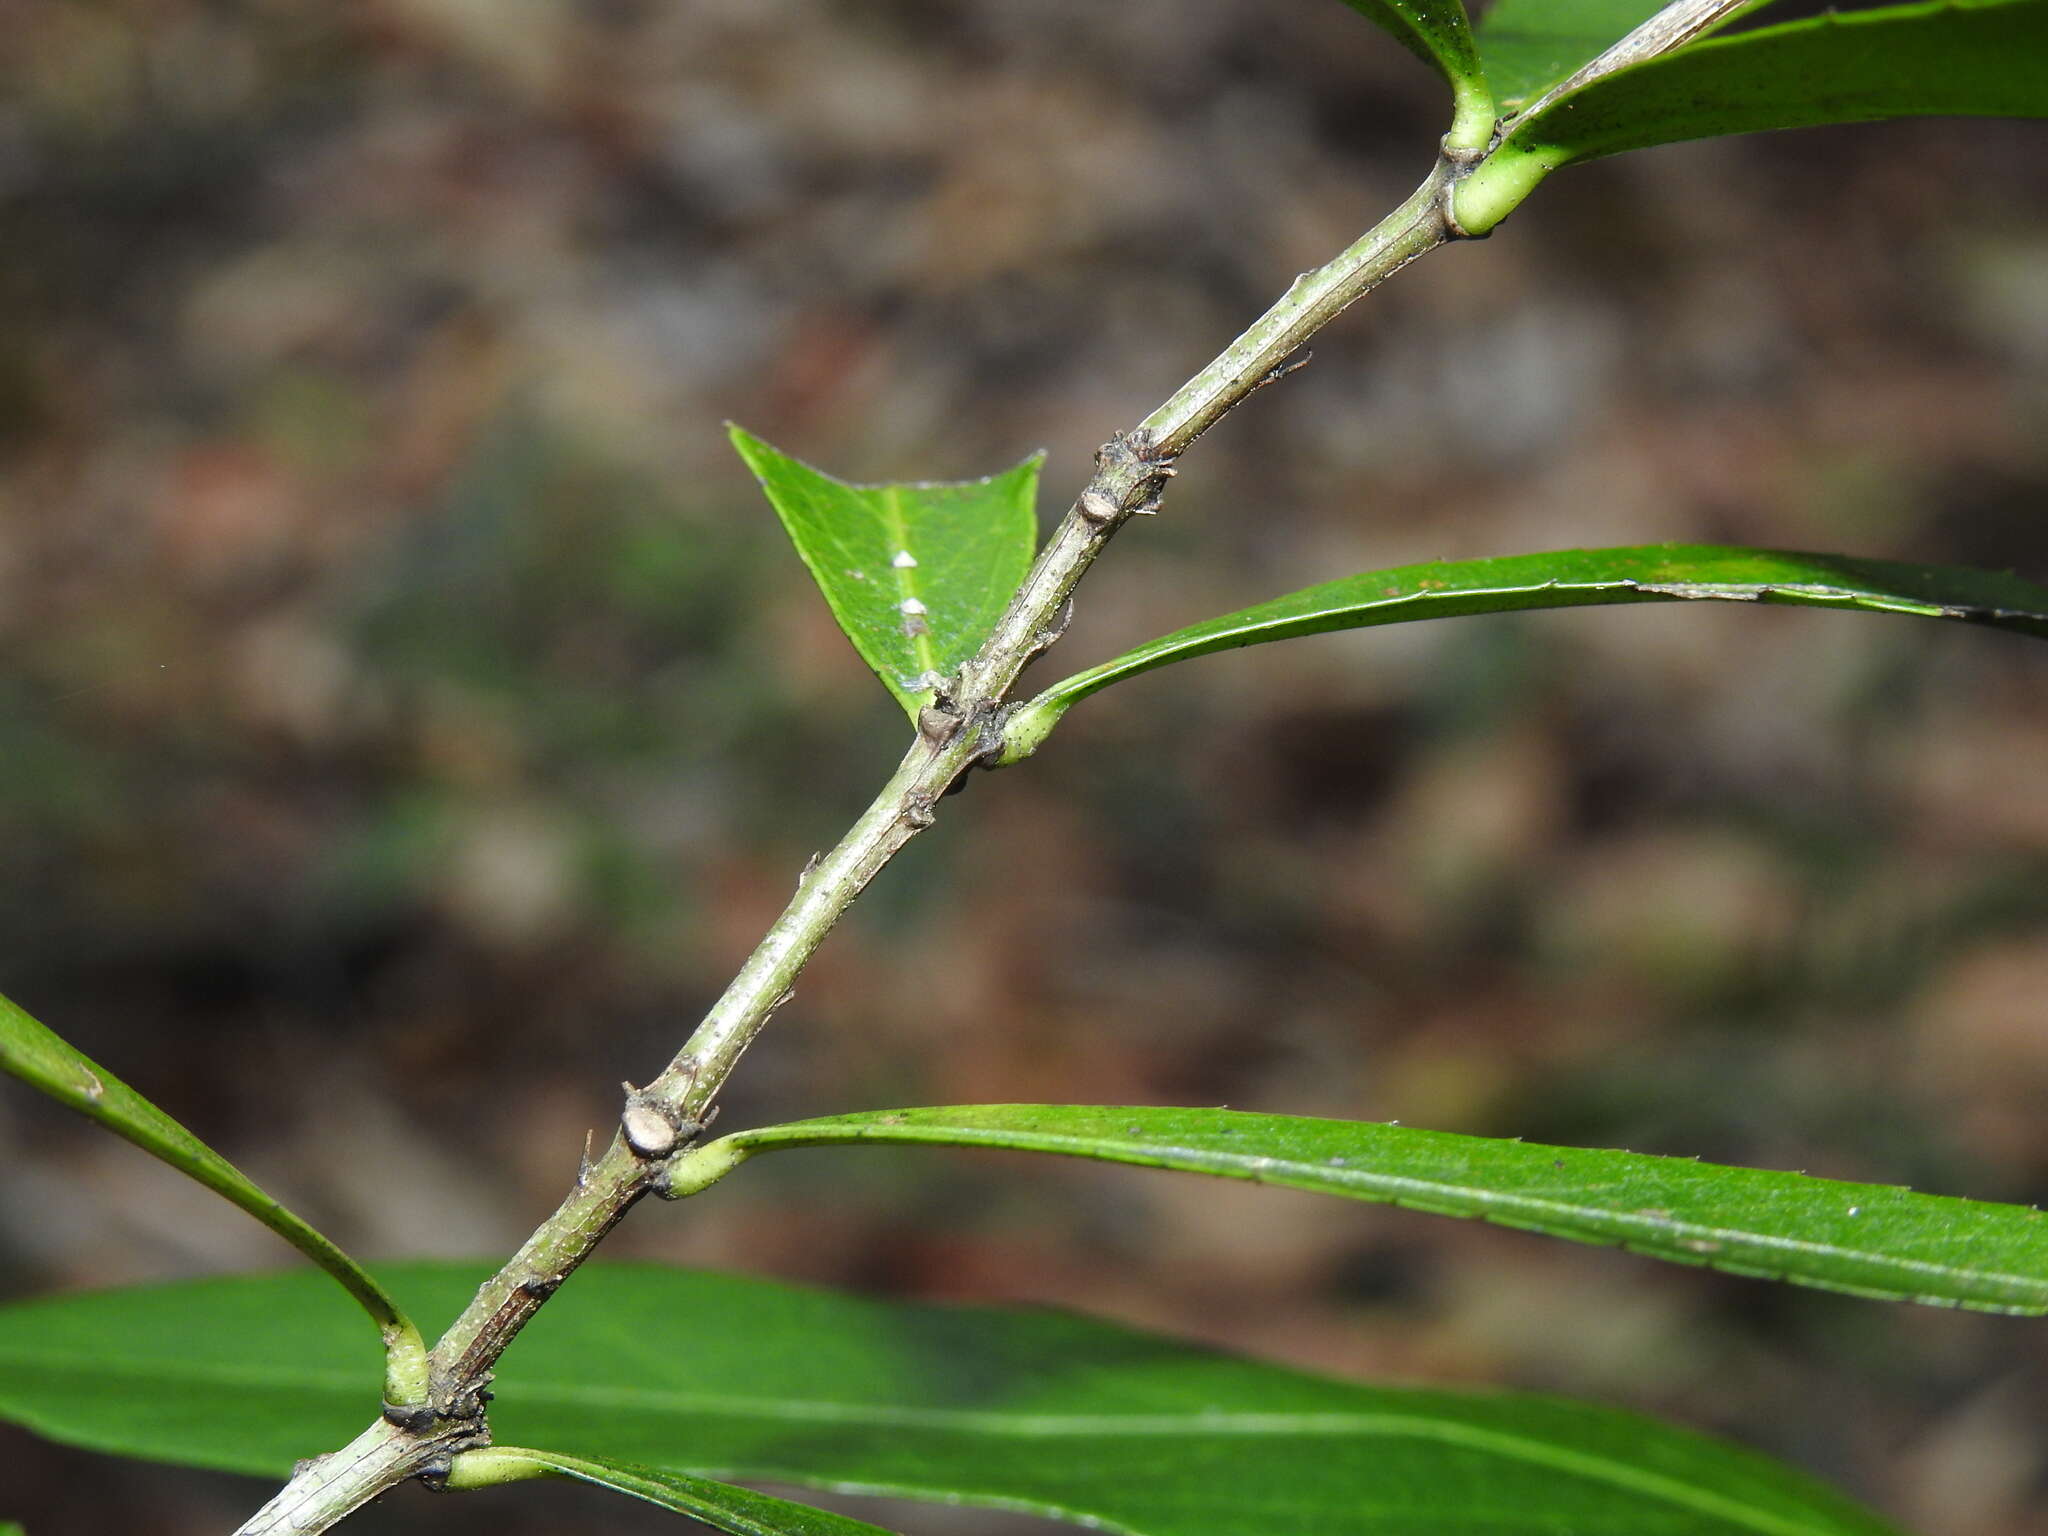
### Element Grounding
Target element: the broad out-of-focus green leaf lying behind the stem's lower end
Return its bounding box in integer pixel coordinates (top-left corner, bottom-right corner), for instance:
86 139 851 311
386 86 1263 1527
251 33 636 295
0 1264 1892 1536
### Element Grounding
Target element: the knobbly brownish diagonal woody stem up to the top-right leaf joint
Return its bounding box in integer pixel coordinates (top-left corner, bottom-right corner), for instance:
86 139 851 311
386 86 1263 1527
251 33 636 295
238 156 1462 1536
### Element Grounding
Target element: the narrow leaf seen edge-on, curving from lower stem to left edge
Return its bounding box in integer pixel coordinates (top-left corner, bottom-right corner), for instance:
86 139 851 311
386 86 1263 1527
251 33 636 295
0 997 426 1407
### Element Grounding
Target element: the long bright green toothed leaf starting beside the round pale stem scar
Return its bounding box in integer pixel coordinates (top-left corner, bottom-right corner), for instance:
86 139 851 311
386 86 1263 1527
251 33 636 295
676 1104 2048 1315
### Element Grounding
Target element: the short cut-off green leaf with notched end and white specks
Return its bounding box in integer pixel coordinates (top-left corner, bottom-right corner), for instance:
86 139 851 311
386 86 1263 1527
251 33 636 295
731 426 1044 719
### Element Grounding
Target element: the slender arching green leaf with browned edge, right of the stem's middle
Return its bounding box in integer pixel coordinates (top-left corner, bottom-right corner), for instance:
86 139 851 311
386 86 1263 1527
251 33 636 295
1001 548 2048 762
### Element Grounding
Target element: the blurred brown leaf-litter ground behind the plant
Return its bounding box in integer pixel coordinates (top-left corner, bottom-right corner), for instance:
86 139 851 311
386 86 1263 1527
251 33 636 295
0 0 2048 1536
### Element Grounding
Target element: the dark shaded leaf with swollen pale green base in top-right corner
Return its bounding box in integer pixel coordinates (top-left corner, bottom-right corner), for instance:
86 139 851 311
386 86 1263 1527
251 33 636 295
1456 0 2048 233
